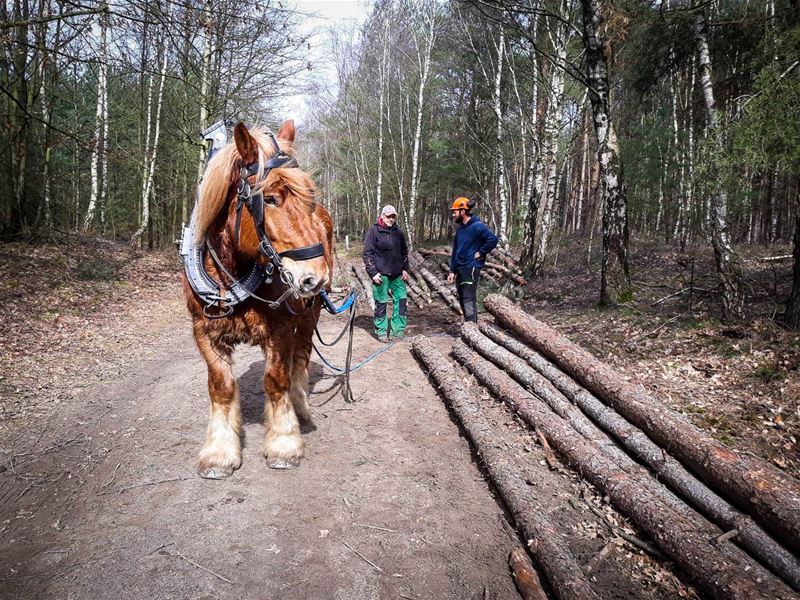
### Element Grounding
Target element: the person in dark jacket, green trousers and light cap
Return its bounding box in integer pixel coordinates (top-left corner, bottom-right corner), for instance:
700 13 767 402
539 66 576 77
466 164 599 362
364 204 408 342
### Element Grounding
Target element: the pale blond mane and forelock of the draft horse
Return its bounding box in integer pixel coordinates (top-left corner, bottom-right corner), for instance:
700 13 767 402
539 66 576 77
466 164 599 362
192 129 316 243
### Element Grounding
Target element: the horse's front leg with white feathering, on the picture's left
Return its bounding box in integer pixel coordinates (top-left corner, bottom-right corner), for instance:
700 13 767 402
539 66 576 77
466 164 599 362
194 323 242 479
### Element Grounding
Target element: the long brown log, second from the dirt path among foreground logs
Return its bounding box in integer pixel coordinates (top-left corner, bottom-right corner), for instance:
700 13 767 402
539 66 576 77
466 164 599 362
453 342 798 600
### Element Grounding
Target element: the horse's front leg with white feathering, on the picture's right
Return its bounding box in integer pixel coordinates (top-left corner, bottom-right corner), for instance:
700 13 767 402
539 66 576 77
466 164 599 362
264 331 304 469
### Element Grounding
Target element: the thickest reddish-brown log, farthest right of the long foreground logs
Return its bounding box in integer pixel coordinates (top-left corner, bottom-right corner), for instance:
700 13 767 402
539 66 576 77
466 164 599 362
484 294 800 553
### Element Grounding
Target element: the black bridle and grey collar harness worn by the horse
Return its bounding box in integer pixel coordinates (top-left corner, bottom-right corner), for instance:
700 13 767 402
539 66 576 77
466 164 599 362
181 133 325 319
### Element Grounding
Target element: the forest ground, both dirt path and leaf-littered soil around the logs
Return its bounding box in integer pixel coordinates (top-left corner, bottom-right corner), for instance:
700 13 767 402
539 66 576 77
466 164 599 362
0 240 800 599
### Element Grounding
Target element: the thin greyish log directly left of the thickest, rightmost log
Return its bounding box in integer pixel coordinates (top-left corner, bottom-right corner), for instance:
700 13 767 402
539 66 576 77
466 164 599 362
478 323 800 591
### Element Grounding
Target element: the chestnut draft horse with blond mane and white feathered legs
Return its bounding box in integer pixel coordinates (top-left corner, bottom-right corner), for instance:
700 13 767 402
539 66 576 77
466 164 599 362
183 121 333 479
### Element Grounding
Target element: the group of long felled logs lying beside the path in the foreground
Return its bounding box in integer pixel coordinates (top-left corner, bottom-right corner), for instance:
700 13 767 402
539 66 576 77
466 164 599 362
413 295 800 598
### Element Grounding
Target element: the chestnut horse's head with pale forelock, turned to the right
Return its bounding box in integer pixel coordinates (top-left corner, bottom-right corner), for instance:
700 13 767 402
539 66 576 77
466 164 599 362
198 121 332 297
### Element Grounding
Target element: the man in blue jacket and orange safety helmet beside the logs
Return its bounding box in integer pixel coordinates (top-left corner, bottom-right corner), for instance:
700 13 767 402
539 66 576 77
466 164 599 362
447 197 497 323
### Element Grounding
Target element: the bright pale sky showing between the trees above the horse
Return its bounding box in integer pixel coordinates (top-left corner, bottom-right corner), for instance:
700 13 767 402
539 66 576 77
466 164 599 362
283 0 371 125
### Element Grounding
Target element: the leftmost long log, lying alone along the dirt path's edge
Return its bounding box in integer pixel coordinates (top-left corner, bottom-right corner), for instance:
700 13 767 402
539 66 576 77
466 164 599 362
411 336 598 600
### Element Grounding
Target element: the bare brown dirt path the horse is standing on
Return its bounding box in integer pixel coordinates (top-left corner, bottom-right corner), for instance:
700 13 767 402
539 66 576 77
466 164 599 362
0 290 532 598
